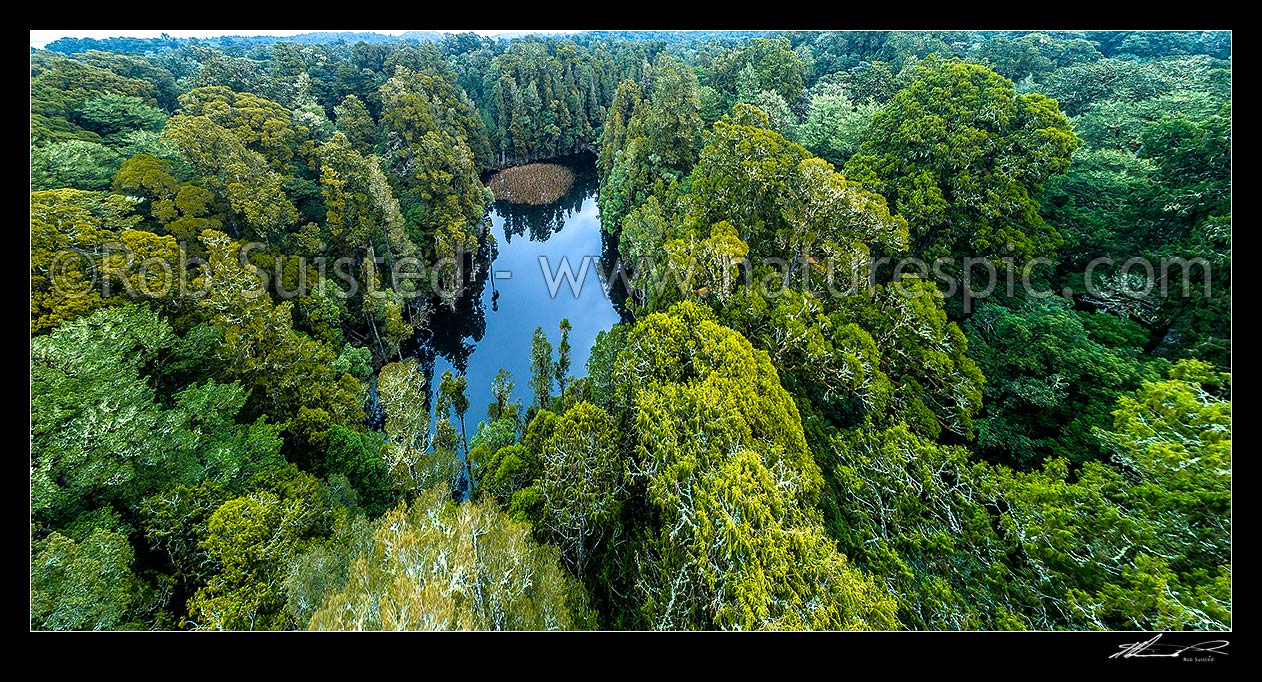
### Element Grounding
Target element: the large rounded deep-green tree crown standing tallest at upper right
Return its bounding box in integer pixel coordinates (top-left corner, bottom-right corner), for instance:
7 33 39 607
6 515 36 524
846 59 1082 260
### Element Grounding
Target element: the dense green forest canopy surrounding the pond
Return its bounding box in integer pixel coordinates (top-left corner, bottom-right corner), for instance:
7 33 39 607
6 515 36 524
29 30 1232 630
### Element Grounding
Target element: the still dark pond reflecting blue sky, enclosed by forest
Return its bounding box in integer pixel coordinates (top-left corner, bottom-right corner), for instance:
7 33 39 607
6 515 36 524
416 154 626 431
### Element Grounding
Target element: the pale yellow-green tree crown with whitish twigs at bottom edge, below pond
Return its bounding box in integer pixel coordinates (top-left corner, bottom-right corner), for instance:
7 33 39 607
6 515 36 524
309 489 587 630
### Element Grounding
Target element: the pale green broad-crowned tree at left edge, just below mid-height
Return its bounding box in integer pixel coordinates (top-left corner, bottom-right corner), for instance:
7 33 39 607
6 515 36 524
30 300 288 525
